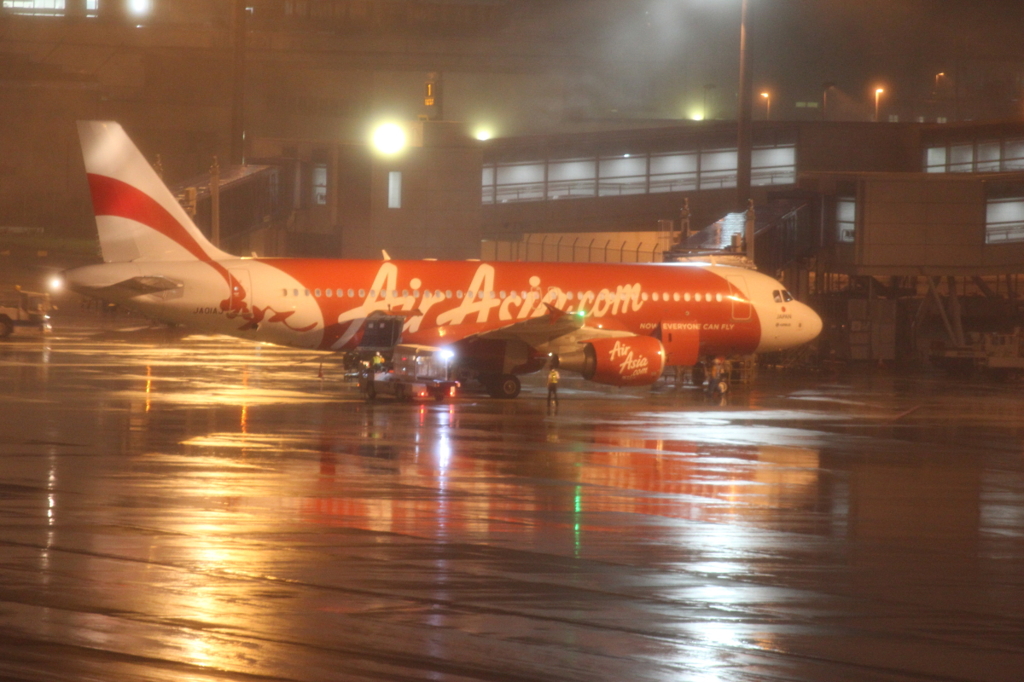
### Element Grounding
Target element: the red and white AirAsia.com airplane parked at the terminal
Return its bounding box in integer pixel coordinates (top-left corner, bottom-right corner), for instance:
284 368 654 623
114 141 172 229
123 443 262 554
65 121 821 398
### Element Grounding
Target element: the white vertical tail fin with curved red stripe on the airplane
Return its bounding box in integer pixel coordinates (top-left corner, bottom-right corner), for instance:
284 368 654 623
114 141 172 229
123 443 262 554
78 121 236 263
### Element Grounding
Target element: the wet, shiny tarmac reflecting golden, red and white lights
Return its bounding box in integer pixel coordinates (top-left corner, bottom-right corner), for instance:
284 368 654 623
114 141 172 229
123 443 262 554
0 329 1024 682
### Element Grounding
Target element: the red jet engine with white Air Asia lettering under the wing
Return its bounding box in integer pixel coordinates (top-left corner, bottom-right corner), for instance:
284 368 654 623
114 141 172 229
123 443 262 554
558 336 665 386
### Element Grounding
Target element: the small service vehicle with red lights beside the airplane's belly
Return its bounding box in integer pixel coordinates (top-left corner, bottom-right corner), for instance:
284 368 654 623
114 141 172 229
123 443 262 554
359 344 459 402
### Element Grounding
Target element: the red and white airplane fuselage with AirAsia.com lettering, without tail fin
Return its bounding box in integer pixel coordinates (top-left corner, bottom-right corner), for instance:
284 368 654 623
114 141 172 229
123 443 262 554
67 258 820 354
